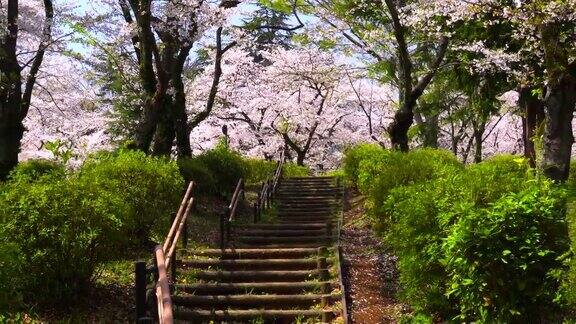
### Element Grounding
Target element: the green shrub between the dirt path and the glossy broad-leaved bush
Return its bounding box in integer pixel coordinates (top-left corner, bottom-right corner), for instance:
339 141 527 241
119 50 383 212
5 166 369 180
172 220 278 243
377 175 464 317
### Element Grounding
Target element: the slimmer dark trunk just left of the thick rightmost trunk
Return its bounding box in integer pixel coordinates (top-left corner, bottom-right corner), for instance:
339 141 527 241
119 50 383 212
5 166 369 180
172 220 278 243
518 86 545 168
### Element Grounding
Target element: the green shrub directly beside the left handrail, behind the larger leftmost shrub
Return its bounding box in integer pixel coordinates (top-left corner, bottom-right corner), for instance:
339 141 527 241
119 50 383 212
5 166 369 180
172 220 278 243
78 150 184 245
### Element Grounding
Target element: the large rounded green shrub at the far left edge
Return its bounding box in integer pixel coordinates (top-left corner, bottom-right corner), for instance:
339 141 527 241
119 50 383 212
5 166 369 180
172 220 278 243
0 177 126 302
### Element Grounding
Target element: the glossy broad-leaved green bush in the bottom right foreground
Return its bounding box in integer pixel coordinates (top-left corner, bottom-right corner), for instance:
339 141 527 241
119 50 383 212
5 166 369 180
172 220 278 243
444 180 568 322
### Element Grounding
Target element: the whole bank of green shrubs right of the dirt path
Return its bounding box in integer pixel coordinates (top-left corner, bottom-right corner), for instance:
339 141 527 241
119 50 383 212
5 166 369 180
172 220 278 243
344 147 576 322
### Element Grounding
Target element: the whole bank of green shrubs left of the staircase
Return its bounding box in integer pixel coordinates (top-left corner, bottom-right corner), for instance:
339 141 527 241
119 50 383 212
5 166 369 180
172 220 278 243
0 150 184 311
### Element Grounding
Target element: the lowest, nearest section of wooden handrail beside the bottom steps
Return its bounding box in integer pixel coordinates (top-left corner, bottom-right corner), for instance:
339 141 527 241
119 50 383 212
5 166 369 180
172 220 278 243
154 245 174 324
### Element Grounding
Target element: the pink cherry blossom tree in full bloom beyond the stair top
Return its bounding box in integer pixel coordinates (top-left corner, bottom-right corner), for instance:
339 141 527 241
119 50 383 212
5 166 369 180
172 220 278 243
191 48 392 168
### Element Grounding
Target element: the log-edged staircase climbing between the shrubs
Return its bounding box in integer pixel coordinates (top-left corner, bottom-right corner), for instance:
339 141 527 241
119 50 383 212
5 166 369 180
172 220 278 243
172 177 345 323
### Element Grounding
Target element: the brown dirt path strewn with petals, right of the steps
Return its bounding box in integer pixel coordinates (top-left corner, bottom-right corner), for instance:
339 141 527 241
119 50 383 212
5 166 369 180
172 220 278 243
342 196 408 324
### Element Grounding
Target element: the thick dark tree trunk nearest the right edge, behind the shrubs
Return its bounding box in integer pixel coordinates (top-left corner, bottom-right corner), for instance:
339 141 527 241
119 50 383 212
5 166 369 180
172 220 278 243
542 72 576 182
